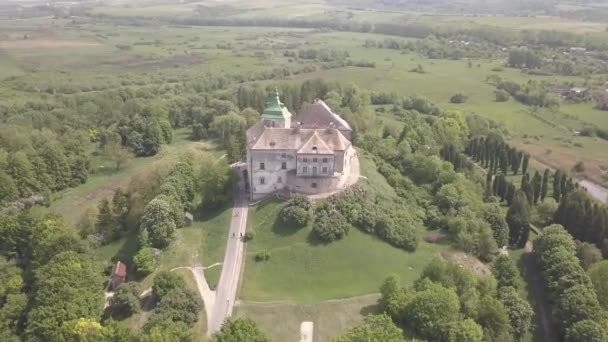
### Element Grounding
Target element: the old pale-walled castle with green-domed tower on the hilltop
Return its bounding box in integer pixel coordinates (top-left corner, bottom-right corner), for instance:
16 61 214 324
246 92 359 200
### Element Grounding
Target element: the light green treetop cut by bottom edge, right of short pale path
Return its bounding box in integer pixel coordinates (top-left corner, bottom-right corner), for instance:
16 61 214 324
334 314 406 342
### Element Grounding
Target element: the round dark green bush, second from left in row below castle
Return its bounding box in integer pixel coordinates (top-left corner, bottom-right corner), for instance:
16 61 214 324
312 202 350 242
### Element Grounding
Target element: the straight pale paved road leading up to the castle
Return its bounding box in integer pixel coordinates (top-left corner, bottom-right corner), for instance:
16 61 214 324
207 164 249 336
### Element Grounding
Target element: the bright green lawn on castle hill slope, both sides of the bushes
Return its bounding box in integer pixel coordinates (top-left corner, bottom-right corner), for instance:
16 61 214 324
240 155 448 303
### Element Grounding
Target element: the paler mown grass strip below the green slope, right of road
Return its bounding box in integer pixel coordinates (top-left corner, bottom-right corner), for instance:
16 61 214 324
234 294 380 341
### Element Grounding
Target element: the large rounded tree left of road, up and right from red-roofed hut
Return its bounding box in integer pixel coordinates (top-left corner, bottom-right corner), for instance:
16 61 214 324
139 199 176 248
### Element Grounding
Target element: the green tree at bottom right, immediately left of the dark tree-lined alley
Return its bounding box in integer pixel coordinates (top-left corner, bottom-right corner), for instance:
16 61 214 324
498 286 534 342
